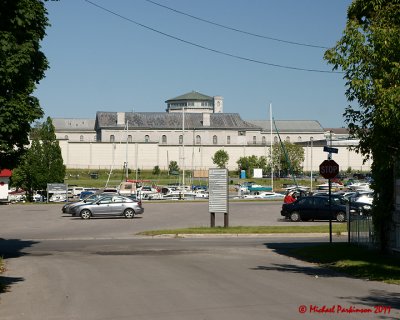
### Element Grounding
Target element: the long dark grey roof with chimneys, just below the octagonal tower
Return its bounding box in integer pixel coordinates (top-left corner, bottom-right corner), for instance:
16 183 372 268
96 111 260 130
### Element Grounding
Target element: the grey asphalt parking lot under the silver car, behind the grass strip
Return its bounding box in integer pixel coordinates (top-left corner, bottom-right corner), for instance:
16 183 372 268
0 201 327 239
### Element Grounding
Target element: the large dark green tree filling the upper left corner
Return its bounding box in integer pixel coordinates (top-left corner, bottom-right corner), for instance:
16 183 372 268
0 0 49 169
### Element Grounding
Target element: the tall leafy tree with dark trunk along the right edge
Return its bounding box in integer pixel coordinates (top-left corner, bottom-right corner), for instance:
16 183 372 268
324 0 400 249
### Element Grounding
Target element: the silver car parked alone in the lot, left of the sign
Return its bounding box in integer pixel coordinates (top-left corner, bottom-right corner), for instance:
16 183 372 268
70 195 144 219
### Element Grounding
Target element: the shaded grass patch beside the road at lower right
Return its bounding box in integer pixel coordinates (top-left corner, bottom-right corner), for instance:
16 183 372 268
289 243 400 284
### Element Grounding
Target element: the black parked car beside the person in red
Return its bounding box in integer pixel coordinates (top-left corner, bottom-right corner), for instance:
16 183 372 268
281 196 358 222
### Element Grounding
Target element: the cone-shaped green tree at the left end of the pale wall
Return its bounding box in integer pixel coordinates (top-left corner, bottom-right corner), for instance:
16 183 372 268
12 118 65 196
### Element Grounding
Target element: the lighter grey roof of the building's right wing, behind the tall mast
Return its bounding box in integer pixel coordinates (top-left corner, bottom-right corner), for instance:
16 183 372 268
246 120 325 133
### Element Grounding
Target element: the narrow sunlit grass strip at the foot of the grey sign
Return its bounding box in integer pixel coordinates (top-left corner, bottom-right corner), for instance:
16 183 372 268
138 223 347 236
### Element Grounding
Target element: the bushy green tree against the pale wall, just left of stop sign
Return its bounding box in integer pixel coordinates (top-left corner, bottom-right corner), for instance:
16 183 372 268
272 141 304 174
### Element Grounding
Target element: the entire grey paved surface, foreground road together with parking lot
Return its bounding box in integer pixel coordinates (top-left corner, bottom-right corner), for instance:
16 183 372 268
0 203 400 320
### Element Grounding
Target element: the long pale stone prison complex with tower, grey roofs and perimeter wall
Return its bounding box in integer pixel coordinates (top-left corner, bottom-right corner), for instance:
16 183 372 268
53 92 369 171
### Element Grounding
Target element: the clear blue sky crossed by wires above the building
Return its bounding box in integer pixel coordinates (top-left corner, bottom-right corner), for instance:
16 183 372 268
35 0 351 128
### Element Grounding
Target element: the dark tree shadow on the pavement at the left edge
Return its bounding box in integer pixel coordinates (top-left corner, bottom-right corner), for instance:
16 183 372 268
0 238 38 294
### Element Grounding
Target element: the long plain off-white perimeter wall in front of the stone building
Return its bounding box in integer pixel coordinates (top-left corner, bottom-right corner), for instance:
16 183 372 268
59 140 371 172
